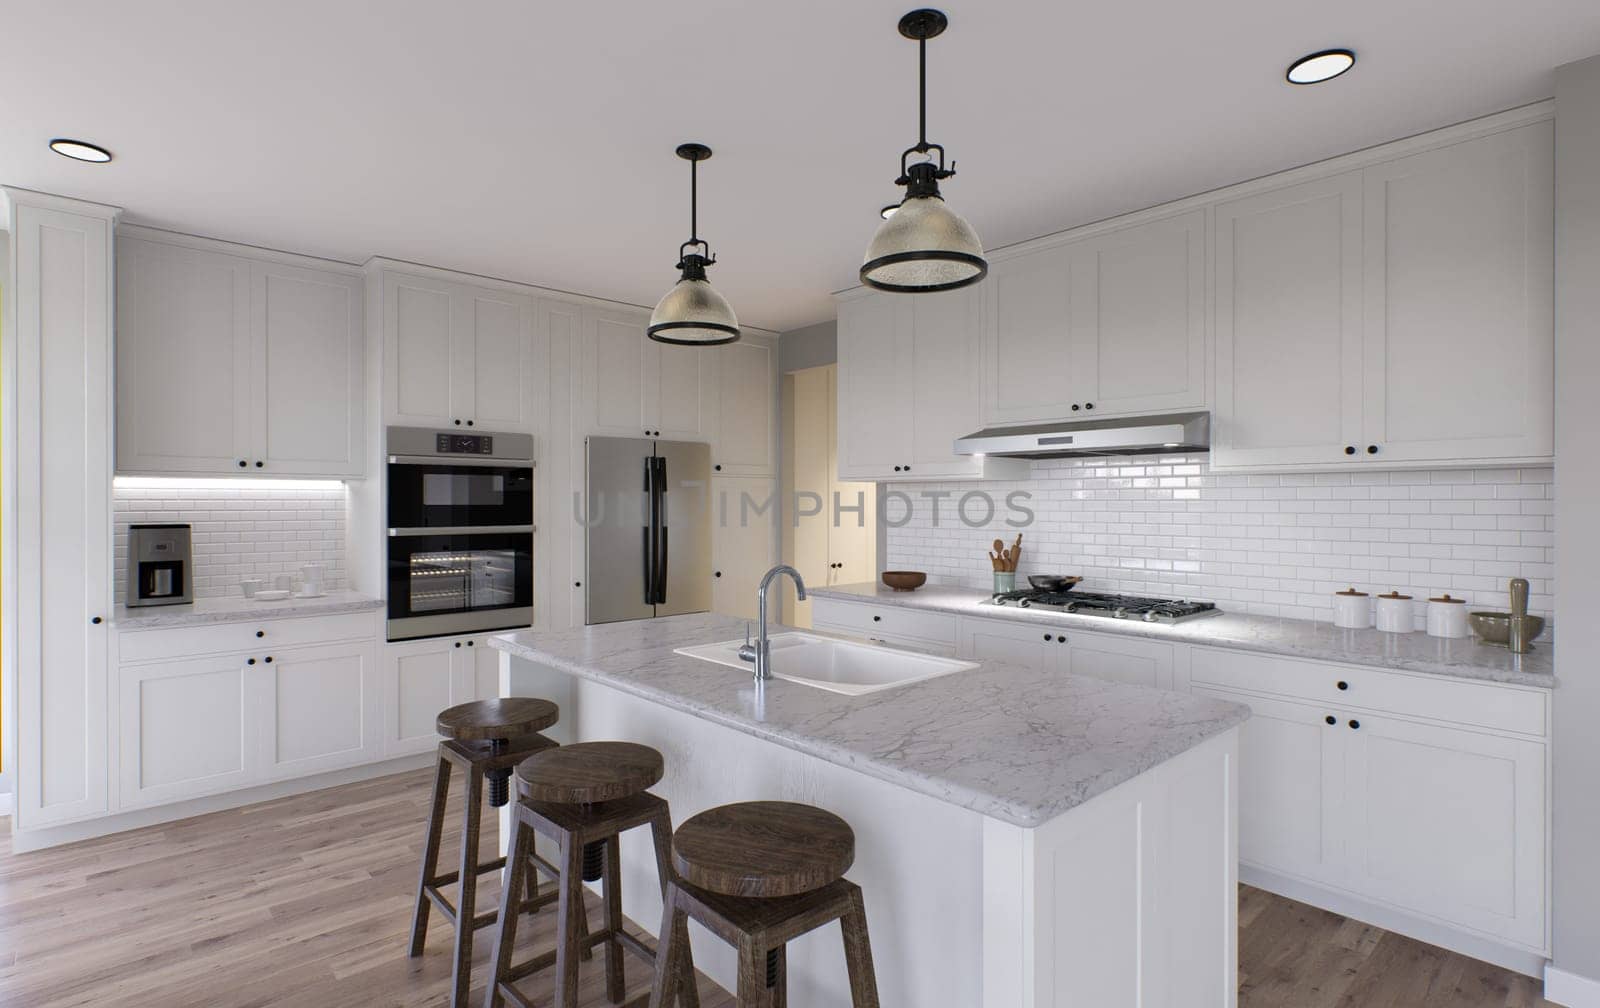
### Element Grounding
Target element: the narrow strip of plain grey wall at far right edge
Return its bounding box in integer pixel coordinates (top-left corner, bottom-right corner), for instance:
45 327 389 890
1550 58 1600 1003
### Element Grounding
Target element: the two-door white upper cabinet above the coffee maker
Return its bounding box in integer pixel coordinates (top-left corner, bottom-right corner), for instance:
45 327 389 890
117 230 366 477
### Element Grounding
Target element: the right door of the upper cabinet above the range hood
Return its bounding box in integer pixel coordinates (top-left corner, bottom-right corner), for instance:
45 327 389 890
1077 210 1206 416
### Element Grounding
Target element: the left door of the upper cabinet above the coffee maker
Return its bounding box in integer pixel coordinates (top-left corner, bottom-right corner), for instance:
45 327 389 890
117 238 253 474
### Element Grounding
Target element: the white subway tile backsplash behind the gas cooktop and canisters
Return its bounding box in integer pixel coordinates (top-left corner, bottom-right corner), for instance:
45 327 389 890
880 453 1555 627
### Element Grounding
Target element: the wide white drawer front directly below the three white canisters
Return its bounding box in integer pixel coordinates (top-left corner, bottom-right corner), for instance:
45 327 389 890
1189 648 1549 736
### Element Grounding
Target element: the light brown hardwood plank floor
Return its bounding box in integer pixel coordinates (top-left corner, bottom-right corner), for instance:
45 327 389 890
0 770 1554 1008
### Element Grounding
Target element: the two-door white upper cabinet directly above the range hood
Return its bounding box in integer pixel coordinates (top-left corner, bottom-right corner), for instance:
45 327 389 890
982 210 1206 424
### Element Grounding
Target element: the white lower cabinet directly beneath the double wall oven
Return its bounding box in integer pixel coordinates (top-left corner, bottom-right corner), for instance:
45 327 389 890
379 635 499 757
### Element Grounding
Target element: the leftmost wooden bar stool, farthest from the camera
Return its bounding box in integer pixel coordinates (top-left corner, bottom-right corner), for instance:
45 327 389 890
411 696 560 1006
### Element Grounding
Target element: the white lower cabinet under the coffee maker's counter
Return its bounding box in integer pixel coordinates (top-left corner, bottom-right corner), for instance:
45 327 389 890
117 619 381 810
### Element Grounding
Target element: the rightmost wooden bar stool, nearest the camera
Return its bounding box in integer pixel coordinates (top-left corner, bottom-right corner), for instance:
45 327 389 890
650 802 878 1008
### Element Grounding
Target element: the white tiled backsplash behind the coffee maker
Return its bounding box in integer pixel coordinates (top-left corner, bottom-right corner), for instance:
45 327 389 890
112 477 346 603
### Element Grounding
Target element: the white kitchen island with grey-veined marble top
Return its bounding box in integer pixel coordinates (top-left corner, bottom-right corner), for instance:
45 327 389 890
493 614 1248 1008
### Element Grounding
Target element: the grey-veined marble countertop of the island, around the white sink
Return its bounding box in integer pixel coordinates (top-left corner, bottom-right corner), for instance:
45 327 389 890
490 613 1250 827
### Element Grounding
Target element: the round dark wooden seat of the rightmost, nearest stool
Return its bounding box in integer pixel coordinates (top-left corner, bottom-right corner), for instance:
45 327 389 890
672 806 856 896
